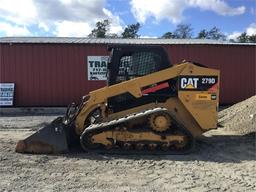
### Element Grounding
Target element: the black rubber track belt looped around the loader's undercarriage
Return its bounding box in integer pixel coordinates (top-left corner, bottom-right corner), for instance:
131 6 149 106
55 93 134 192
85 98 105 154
80 108 194 155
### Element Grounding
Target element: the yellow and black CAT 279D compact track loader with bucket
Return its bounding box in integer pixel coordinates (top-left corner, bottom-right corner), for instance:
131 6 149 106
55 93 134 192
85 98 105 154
16 45 219 154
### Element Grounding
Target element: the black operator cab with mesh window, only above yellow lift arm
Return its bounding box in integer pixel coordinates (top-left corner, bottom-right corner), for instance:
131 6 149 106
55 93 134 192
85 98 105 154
107 45 170 86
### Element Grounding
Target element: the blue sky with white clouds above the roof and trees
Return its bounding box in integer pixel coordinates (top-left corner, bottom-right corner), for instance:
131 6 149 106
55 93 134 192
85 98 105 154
0 0 256 39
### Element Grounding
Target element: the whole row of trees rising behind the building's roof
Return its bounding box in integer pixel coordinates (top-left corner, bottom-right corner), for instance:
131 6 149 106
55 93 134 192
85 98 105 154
89 19 256 43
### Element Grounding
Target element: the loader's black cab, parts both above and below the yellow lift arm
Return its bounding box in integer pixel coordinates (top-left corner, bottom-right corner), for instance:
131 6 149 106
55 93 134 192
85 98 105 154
107 45 176 112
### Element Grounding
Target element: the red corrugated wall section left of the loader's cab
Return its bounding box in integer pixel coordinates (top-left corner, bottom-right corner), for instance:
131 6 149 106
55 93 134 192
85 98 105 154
0 44 108 106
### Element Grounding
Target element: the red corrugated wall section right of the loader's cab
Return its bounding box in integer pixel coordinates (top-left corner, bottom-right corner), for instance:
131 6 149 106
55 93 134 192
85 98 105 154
166 45 256 104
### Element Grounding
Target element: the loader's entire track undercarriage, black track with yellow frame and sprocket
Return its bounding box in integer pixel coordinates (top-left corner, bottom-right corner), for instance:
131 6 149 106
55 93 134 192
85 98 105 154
80 108 194 154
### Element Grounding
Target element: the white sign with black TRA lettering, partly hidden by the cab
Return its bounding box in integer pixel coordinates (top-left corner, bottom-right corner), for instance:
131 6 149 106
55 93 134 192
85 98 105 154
87 56 109 81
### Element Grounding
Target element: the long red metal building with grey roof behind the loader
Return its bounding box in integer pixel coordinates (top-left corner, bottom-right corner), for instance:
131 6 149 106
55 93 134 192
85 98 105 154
0 37 256 107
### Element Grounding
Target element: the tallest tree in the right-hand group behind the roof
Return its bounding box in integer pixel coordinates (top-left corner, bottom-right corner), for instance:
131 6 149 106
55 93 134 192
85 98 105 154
173 24 193 39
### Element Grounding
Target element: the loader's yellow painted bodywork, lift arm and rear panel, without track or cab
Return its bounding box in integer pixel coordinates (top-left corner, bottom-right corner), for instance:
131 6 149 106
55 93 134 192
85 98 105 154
75 62 220 136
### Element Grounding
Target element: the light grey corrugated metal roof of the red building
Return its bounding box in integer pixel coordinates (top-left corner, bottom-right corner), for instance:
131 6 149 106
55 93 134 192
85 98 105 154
0 37 256 45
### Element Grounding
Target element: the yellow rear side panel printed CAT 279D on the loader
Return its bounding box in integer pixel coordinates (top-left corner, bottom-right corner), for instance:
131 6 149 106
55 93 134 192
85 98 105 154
178 66 220 130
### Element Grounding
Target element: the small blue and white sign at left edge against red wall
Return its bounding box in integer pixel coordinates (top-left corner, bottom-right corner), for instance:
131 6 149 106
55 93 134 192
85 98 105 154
0 83 14 106
